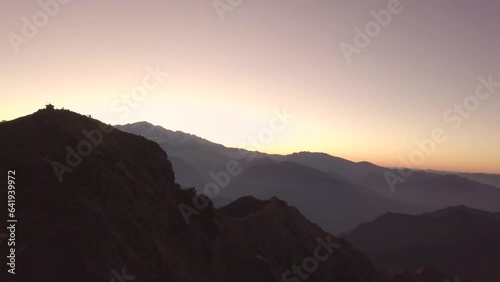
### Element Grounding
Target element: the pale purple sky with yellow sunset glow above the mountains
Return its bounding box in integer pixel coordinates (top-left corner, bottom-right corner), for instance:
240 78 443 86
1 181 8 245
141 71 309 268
0 0 500 173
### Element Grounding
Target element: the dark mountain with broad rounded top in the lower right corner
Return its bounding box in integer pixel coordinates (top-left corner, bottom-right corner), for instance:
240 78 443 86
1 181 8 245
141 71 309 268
346 206 500 282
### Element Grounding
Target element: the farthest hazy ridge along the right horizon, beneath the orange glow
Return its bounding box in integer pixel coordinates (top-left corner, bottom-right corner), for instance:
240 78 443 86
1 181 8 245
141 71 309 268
283 153 500 211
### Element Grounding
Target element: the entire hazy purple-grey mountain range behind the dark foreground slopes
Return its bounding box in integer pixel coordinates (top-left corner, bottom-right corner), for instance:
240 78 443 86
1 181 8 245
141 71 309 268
116 122 500 233
